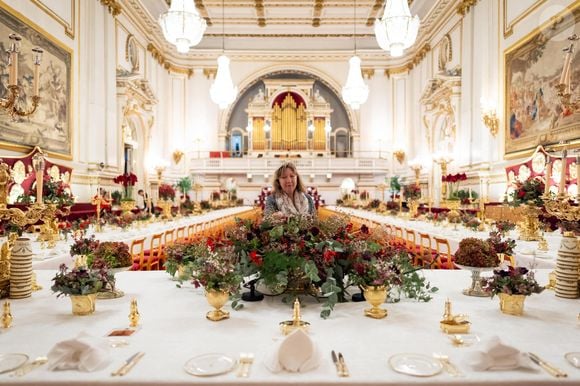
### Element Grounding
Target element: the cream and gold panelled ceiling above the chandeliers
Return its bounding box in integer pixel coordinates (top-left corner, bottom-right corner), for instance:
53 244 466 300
124 0 461 64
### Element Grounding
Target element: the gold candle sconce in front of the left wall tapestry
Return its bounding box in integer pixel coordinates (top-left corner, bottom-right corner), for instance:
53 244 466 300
0 34 43 119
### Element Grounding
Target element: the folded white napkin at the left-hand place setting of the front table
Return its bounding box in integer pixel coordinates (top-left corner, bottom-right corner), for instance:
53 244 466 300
48 332 111 372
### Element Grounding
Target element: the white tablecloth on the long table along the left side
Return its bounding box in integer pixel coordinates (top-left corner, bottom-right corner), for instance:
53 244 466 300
23 206 251 269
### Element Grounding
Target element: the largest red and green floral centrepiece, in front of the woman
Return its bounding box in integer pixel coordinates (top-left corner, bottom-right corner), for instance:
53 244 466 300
227 215 436 318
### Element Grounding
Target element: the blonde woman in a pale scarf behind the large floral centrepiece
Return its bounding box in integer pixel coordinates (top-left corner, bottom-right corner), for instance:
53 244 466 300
264 162 316 217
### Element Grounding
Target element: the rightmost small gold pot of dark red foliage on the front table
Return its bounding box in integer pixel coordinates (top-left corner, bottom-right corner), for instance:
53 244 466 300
484 266 544 315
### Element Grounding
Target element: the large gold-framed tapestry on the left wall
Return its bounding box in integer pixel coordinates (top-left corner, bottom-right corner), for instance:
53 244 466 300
0 3 72 159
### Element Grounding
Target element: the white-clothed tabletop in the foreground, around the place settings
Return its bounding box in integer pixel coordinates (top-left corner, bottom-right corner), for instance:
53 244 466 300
0 270 580 386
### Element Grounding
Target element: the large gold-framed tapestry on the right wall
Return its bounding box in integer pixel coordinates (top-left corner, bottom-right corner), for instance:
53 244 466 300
504 3 580 158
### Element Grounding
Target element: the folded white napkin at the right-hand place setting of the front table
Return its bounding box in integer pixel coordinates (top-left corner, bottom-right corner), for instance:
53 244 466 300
465 336 534 371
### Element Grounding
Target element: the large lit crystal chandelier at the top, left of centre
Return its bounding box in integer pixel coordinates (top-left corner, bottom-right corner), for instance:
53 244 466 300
159 0 207 54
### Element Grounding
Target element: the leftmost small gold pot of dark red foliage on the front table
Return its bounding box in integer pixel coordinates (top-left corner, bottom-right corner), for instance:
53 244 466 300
51 264 114 315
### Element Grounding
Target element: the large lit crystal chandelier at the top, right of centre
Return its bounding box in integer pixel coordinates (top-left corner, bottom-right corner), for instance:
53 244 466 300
375 0 419 57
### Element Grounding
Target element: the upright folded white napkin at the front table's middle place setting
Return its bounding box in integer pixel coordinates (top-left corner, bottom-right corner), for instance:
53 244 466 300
265 329 320 373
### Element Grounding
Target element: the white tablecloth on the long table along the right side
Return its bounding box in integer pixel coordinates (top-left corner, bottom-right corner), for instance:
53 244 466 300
327 206 562 269
